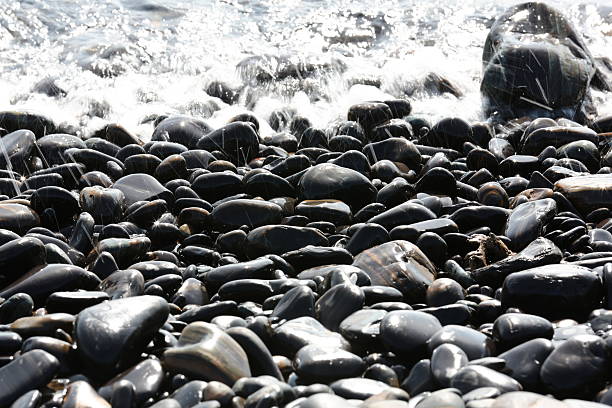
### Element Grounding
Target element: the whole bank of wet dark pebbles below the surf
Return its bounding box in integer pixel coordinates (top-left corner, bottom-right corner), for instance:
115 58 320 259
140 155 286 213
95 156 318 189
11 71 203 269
0 96 612 408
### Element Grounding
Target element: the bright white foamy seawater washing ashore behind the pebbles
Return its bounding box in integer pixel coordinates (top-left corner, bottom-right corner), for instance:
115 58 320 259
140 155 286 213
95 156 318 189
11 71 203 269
0 0 612 140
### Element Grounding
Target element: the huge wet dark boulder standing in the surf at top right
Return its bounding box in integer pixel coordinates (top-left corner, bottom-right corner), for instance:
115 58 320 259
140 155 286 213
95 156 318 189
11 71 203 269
480 2 611 123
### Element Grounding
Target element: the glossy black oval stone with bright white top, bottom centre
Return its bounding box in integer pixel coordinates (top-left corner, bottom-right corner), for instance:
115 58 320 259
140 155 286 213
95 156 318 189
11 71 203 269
293 345 365 383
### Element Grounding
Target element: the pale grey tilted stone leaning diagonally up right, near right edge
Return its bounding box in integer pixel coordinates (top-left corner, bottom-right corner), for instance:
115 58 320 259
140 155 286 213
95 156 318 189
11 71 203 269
504 198 557 251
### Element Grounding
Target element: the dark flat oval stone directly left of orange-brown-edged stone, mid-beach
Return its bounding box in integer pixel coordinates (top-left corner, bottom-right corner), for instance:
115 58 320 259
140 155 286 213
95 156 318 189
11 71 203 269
211 199 282 230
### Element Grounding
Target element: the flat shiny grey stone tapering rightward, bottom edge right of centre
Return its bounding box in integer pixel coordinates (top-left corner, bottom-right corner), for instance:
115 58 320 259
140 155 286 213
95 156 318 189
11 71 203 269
451 365 523 394
